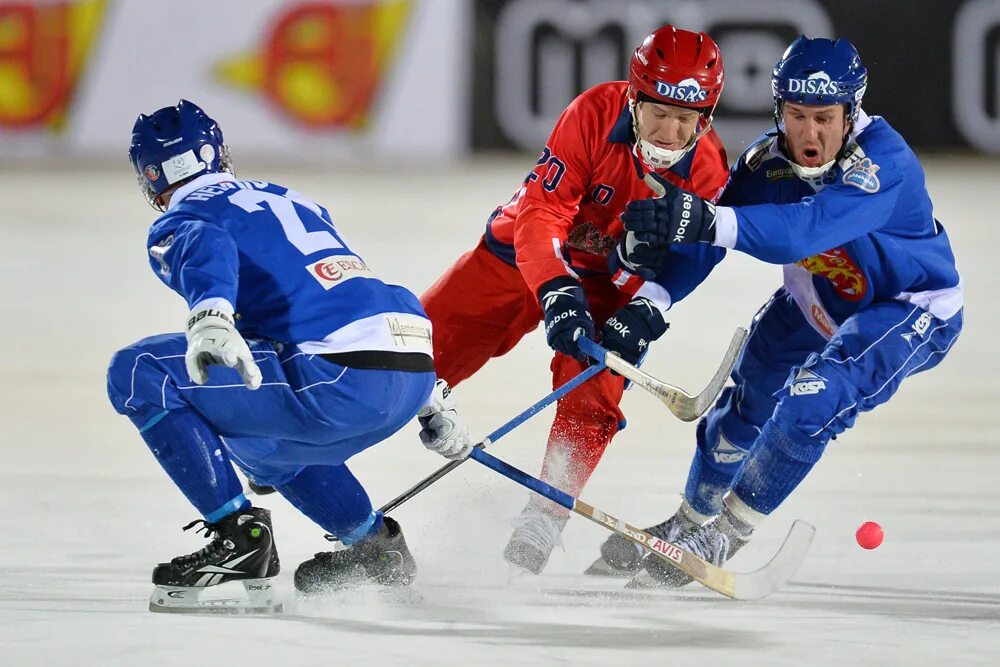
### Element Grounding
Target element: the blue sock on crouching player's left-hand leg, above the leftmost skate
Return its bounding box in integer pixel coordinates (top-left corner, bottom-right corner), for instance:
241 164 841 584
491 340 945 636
133 409 250 523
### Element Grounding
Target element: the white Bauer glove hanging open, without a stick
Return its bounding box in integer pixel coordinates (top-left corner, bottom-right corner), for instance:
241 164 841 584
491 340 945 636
184 308 261 389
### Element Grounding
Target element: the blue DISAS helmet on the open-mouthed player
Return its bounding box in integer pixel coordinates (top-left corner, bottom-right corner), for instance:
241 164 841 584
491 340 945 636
771 35 868 123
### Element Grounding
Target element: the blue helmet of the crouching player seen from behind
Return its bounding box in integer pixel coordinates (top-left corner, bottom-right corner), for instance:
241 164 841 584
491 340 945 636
128 100 232 211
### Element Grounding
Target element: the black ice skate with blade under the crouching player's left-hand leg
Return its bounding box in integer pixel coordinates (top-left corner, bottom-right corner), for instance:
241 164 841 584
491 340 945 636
149 507 281 614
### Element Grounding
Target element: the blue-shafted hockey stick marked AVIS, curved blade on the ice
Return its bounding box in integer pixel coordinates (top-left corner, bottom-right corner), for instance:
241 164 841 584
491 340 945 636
469 448 816 600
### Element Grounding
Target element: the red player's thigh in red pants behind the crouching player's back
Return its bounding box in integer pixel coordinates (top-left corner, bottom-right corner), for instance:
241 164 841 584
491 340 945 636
420 242 542 387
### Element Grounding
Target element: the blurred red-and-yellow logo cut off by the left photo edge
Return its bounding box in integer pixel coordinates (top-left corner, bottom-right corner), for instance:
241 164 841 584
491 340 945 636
0 0 107 129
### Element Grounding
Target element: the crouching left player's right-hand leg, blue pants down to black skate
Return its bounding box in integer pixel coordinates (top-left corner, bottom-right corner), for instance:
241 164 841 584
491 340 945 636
227 369 435 593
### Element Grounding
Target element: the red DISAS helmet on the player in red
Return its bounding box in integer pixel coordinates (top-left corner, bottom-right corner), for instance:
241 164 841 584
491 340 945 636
628 25 726 116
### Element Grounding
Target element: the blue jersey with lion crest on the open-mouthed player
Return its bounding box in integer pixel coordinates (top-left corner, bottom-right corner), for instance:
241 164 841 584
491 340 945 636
716 112 962 339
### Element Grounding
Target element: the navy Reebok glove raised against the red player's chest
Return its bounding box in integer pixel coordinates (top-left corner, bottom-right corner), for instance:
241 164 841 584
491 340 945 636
622 174 715 254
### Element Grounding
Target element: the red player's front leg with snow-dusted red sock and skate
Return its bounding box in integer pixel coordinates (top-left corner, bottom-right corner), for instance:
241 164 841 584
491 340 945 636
504 277 625 574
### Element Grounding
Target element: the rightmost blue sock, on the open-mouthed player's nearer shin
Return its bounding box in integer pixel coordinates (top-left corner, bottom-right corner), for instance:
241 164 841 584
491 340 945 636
733 421 826 514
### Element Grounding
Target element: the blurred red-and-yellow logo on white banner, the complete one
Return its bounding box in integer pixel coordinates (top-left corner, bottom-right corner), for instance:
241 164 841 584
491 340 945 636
217 0 413 129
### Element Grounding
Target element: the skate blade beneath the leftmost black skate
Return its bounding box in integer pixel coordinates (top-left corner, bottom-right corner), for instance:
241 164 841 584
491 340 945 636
149 579 284 615
